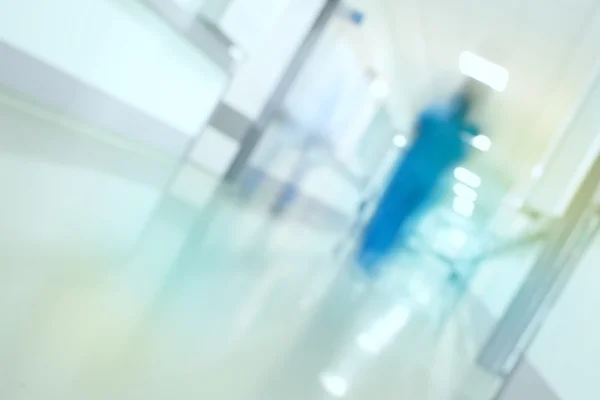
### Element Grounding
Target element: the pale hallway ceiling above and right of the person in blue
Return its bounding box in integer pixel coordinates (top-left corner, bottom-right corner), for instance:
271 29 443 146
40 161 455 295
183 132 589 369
350 0 600 191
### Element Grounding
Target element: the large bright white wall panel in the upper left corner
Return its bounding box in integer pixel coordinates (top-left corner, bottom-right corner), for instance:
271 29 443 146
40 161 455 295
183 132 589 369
0 0 227 135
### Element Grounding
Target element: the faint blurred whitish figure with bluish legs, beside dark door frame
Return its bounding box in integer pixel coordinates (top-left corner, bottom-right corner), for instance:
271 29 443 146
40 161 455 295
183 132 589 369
241 35 368 215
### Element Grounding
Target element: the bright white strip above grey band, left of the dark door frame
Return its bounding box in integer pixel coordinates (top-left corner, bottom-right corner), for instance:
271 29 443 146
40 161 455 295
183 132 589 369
225 0 324 120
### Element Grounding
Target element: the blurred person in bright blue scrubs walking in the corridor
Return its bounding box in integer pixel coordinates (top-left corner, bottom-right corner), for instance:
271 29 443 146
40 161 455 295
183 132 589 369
356 82 481 272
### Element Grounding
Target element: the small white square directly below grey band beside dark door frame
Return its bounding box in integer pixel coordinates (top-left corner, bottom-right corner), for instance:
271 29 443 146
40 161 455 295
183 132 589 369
191 126 240 177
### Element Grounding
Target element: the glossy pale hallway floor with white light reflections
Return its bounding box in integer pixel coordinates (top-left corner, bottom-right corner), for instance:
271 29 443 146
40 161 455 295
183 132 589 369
0 91 499 400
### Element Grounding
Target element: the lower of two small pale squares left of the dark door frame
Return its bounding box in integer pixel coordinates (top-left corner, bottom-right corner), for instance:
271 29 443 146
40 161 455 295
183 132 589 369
170 165 220 208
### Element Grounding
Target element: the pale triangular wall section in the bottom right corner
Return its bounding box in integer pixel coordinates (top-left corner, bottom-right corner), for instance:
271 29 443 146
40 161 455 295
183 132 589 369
527 236 600 400
